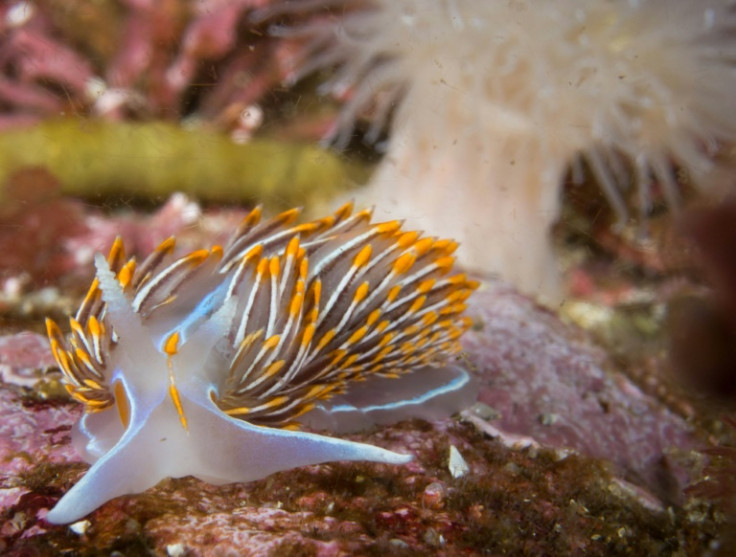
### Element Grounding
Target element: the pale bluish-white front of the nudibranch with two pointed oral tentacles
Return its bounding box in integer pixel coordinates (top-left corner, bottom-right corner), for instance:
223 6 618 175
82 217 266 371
46 380 412 524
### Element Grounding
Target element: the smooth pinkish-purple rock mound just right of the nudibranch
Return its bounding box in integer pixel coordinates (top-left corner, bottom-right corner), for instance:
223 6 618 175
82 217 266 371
462 285 703 501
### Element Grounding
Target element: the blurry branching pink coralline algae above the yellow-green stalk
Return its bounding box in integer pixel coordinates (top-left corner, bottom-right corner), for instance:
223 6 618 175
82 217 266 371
0 0 294 138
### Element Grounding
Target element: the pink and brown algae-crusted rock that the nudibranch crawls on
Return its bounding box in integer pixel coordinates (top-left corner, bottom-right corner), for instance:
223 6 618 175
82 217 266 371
0 276 715 556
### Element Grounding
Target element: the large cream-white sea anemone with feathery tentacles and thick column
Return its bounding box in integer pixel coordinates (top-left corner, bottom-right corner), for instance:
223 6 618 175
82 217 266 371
274 0 736 300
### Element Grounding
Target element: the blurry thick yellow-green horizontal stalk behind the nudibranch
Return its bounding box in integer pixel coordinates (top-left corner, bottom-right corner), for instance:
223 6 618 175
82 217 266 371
0 118 366 208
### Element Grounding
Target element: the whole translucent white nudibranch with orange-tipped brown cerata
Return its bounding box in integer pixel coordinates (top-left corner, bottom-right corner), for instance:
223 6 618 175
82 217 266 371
47 204 477 524
